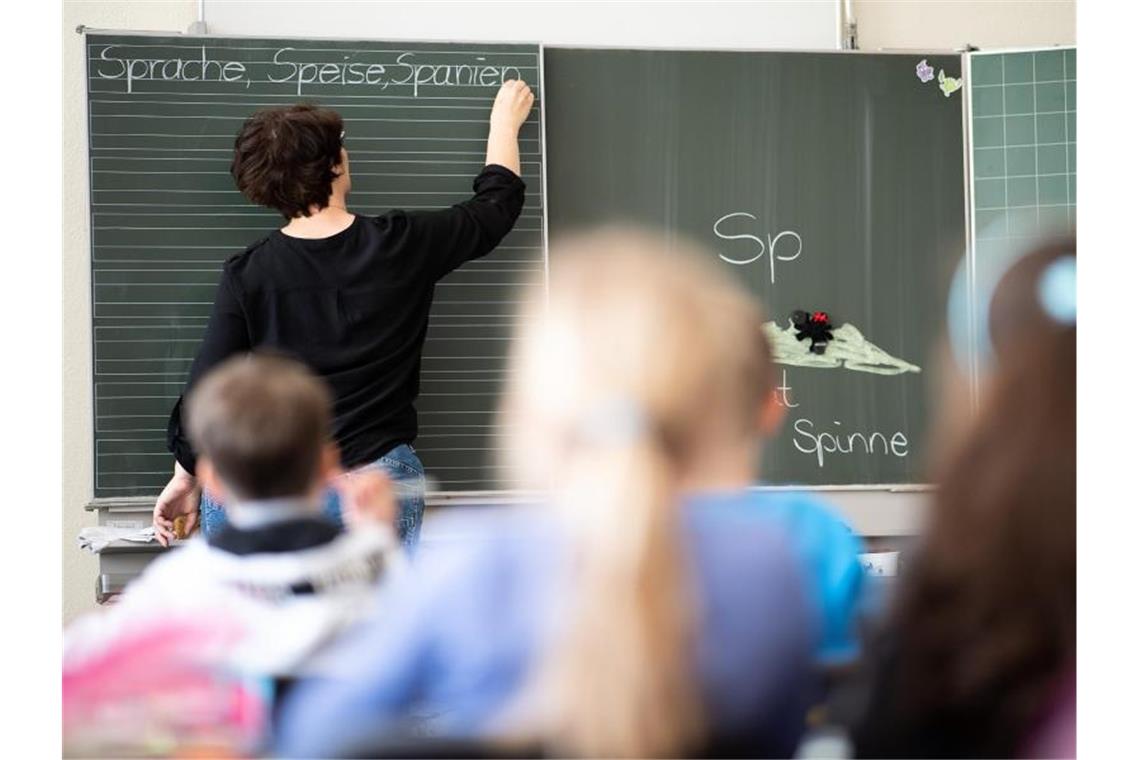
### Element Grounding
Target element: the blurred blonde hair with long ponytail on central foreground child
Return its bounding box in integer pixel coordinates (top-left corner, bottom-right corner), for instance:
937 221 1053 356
504 229 773 757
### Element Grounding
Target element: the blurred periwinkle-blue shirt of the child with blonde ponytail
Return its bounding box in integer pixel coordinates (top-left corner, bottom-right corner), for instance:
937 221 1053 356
278 493 829 757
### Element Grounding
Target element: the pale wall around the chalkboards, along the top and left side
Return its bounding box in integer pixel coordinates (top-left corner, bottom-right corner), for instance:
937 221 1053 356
62 0 1076 620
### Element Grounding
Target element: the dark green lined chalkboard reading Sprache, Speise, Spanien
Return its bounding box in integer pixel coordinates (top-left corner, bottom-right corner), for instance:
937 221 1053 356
87 34 545 497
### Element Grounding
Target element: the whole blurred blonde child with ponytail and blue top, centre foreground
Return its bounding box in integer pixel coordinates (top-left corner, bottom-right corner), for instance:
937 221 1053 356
279 231 860 757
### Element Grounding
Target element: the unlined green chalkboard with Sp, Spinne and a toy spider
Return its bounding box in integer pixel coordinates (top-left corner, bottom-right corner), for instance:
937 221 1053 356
544 48 966 485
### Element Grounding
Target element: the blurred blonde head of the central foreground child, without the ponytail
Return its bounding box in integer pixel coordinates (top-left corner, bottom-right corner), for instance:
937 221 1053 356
505 228 780 496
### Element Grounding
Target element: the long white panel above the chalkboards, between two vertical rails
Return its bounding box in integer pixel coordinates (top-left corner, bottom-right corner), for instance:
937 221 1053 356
205 0 839 49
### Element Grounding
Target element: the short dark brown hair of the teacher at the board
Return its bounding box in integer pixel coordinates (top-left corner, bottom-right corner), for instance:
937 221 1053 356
229 104 344 219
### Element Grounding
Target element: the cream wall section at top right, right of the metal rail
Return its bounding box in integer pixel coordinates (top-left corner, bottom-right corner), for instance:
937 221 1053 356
853 0 1076 50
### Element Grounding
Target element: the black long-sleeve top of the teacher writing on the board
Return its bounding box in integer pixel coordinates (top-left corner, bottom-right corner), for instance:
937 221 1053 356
166 164 526 473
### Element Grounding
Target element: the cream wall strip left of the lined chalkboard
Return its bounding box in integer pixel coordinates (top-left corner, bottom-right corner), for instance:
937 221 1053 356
62 0 198 622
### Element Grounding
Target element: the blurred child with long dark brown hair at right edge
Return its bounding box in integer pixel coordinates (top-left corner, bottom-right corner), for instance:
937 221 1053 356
855 240 1076 758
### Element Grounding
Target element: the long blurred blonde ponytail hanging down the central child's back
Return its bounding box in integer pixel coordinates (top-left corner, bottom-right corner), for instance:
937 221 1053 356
544 433 705 757
